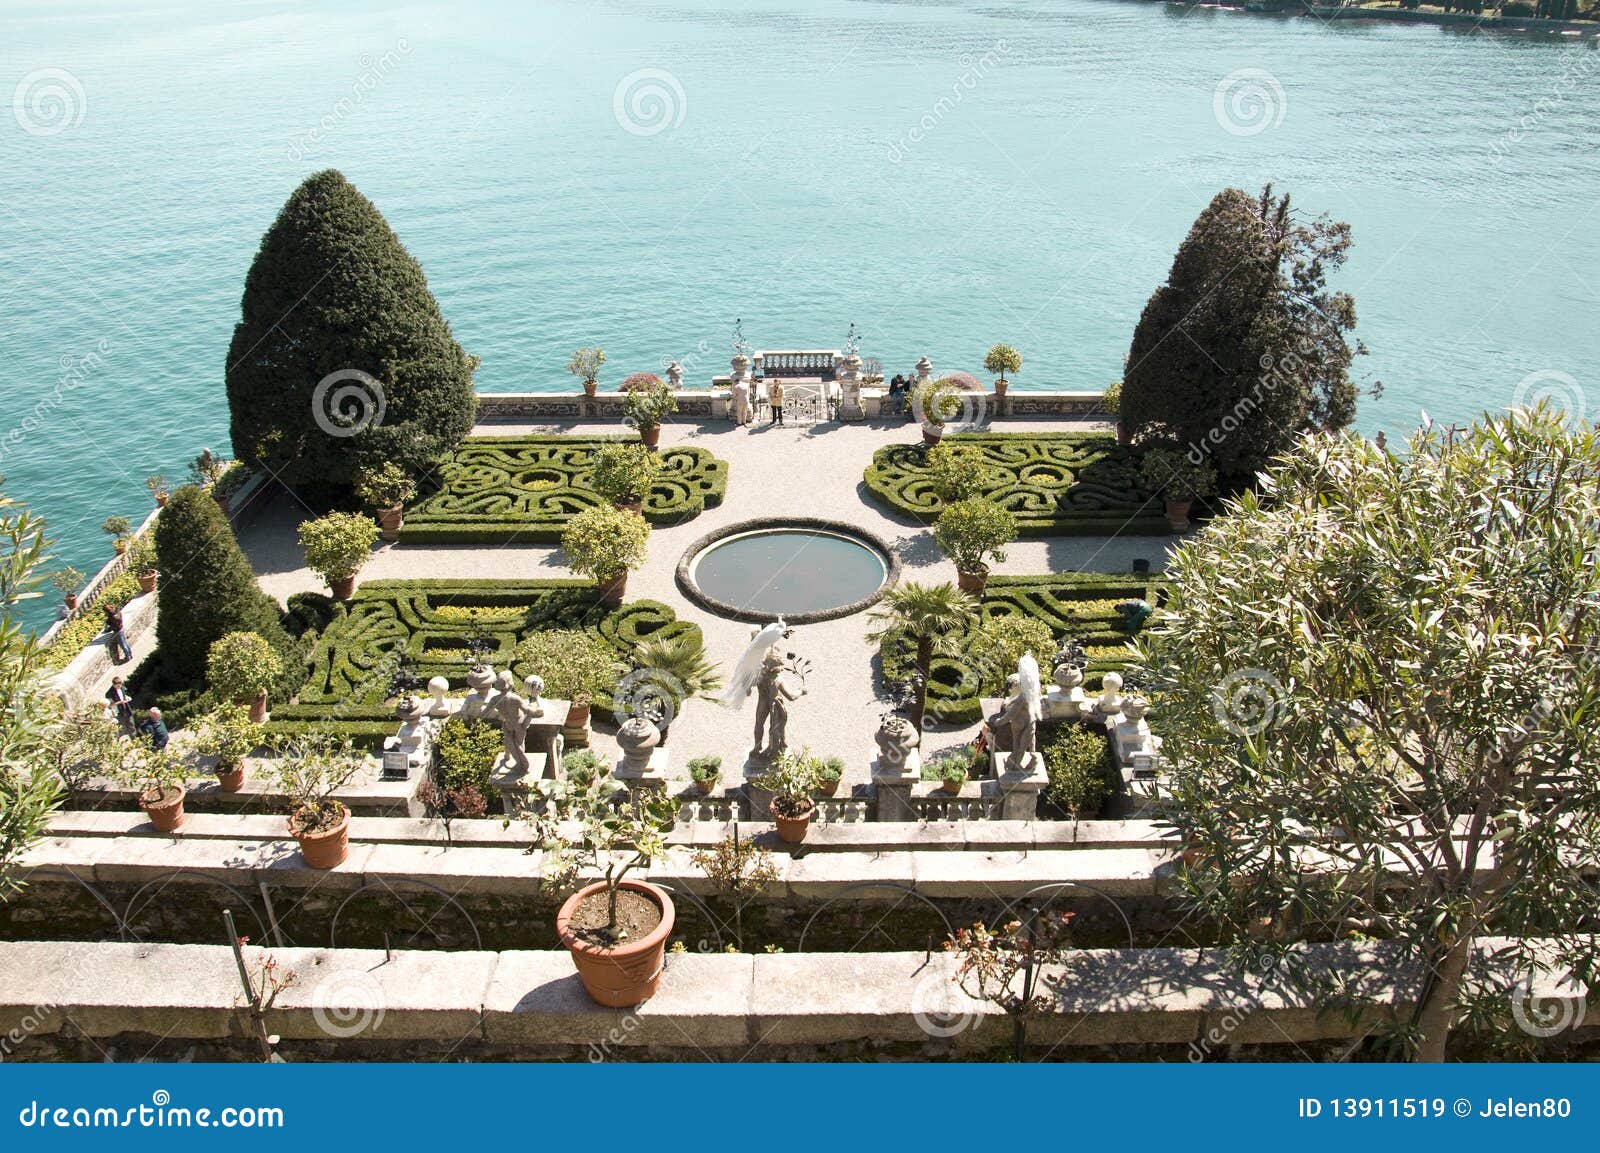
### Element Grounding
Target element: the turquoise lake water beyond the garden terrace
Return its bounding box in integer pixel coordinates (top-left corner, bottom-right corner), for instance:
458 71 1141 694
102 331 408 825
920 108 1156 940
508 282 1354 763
0 0 1600 630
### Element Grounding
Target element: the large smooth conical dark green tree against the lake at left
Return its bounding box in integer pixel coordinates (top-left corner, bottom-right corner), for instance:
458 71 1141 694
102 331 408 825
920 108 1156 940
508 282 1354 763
227 170 477 489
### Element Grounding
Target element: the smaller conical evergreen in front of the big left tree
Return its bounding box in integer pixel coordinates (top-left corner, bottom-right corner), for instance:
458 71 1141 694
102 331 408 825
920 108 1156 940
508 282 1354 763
155 485 299 684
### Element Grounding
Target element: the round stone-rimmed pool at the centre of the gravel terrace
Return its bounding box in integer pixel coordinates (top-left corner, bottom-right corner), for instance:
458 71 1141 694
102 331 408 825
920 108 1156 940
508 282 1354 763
678 518 899 624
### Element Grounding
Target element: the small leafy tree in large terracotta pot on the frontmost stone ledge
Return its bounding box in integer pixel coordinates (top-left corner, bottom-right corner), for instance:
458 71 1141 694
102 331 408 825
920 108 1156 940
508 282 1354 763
525 766 677 1009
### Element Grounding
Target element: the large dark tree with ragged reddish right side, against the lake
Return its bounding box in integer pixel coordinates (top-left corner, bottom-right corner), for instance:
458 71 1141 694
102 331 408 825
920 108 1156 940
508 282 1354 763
1120 186 1365 478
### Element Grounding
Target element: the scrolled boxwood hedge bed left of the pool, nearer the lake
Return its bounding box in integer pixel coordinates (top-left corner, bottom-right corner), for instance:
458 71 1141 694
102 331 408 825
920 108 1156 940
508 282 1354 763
400 437 728 544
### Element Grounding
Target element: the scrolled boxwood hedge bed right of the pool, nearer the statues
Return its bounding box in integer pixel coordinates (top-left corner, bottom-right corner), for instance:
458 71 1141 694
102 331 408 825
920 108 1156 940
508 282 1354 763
878 573 1166 724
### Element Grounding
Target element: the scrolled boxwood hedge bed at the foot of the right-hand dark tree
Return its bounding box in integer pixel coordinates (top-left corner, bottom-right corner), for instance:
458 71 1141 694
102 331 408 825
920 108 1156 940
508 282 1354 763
866 432 1173 536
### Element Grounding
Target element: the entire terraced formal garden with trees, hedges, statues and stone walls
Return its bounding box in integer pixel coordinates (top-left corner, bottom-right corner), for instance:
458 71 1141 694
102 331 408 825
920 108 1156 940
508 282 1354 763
0 173 1600 1060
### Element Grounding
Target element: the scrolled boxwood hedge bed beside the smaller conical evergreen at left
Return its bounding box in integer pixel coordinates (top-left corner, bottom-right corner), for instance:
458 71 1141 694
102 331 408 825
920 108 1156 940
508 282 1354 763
267 580 699 748
